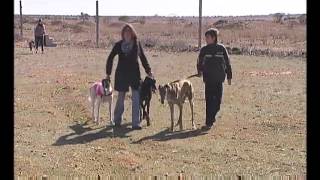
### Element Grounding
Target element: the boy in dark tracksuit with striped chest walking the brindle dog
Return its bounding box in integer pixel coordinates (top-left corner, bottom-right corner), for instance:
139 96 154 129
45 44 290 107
197 28 232 130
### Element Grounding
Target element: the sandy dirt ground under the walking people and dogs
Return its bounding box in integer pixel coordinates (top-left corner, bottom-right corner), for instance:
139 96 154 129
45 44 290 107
14 47 306 176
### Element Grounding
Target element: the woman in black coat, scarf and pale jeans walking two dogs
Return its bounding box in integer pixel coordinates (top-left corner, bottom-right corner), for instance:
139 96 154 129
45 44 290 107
106 24 152 129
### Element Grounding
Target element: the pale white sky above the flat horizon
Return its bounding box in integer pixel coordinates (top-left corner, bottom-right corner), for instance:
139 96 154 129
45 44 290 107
14 0 307 16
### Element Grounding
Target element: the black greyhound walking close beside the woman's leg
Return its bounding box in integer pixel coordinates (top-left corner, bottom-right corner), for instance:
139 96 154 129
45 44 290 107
140 76 157 126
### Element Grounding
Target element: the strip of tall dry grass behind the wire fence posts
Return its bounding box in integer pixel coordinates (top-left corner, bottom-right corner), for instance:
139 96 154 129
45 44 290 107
16 17 306 57
